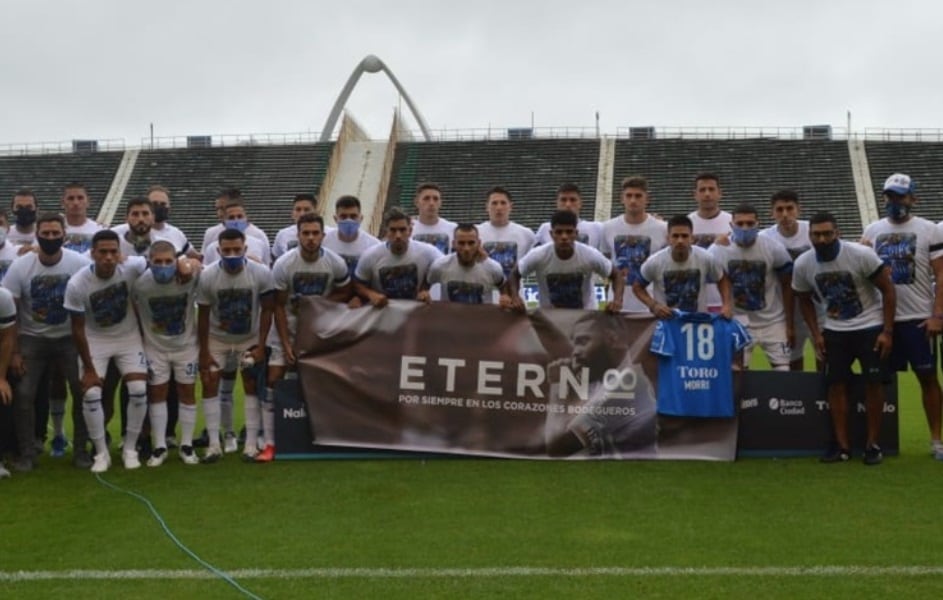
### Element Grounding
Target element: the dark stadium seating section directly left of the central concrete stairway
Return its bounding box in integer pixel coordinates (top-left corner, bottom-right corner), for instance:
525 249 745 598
123 143 333 245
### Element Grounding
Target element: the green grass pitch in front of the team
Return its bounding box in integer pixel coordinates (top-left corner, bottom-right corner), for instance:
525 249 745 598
0 354 943 598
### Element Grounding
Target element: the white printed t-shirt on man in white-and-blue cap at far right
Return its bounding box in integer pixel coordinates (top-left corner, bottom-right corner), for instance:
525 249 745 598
862 217 943 321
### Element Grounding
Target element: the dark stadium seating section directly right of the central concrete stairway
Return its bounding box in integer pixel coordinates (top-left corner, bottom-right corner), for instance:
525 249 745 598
386 139 599 230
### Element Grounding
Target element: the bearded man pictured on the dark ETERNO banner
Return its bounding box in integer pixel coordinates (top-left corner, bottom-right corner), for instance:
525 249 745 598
545 313 658 458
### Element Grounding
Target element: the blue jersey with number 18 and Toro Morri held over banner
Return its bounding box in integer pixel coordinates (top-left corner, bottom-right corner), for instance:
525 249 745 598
651 311 750 417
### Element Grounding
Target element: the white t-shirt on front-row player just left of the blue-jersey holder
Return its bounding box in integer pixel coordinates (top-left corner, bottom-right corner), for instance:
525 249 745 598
517 242 612 310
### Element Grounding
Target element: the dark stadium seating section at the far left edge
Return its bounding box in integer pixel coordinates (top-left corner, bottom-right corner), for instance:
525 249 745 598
0 152 122 217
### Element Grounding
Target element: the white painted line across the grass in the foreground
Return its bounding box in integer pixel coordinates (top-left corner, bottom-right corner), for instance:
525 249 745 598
0 565 943 582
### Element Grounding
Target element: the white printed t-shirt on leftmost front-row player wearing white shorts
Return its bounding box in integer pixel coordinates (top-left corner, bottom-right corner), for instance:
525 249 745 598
63 256 147 354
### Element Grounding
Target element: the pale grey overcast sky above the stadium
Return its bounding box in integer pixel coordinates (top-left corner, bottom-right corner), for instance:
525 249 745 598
0 0 943 145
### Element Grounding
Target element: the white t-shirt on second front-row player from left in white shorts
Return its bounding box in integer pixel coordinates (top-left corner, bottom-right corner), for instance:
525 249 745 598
131 269 199 353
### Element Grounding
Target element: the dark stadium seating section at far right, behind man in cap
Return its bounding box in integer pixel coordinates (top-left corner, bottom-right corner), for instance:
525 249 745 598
865 142 943 222
